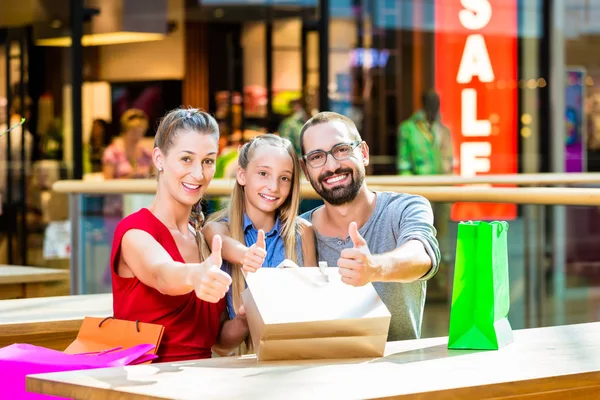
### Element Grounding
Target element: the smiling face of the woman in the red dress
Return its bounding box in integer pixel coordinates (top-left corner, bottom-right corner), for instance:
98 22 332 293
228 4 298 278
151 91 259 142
154 129 218 207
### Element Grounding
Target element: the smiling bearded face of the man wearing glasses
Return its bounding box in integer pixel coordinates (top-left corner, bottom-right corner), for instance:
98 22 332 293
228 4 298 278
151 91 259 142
302 121 369 205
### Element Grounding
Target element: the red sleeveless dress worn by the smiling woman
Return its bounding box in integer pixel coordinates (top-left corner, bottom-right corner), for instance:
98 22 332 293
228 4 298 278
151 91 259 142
111 208 225 362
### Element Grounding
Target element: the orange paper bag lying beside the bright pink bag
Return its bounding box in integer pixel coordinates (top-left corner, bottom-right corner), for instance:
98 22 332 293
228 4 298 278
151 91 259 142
64 317 165 354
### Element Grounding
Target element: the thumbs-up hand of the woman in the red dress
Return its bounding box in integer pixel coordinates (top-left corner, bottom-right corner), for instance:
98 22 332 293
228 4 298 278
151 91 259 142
189 235 231 303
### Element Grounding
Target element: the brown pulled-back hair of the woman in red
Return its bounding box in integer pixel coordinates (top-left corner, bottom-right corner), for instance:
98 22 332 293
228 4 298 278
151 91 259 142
154 107 219 261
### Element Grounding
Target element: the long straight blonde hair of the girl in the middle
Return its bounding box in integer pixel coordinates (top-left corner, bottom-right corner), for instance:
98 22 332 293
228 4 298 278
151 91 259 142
210 134 300 340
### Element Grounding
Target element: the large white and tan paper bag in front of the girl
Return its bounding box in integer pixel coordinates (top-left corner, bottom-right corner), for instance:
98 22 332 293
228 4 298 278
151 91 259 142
242 267 391 360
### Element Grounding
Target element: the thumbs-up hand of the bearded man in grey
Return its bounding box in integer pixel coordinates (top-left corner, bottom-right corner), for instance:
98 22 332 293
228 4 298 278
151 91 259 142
338 222 377 286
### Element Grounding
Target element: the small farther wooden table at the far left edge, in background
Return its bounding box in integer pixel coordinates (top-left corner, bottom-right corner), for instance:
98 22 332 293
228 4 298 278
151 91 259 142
0 265 69 300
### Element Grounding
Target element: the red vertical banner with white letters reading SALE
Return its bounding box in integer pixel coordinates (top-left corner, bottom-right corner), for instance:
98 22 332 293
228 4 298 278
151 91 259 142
435 0 518 221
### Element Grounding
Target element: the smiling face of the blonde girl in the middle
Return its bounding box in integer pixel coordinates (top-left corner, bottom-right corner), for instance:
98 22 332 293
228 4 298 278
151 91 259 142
237 145 294 214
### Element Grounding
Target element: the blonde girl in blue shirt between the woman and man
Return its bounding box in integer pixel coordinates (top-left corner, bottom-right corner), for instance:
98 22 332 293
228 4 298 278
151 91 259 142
203 134 317 318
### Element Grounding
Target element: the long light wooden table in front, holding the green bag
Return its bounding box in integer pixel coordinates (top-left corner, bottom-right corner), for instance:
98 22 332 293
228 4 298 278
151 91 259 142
27 323 600 400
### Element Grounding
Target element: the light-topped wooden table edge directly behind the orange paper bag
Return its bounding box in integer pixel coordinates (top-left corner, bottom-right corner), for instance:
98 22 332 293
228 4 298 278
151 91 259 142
0 294 113 351
